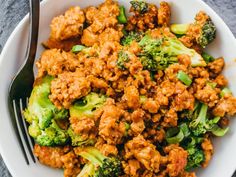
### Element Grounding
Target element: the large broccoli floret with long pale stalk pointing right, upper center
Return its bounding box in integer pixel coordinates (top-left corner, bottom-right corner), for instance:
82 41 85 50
139 34 206 71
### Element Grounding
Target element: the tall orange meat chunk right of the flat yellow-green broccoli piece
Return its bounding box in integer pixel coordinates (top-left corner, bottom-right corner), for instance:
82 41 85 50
99 104 125 145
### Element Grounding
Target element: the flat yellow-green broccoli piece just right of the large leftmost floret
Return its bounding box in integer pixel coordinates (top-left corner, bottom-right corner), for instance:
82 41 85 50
69 92 106 118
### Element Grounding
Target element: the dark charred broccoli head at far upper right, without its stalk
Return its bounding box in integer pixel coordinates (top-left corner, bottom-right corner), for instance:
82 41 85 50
197 19 216 48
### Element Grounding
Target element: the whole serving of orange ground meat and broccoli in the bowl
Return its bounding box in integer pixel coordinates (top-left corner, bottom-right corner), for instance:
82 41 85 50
24 0 236 177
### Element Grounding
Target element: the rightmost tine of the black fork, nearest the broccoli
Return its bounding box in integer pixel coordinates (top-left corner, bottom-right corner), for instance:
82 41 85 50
20 98 36 163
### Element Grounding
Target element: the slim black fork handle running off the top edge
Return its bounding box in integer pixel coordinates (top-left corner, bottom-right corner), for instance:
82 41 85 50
25 0 40 68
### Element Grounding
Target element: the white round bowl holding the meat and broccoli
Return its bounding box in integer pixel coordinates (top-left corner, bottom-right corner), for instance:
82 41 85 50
0 0 236 177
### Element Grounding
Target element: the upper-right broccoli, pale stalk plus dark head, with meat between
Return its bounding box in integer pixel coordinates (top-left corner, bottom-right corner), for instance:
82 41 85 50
170 13 216 48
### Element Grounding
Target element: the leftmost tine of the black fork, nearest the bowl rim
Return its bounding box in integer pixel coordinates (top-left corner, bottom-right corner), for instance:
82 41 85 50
12 100 29 165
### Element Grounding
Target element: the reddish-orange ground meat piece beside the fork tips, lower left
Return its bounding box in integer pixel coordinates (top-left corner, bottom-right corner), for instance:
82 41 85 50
34 144 70 168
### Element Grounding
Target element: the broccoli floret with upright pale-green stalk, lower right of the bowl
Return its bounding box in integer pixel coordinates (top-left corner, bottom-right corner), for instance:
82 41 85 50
189 104 228 136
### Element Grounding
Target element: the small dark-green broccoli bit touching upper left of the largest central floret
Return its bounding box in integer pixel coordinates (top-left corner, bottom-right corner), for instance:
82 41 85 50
121 31 143 46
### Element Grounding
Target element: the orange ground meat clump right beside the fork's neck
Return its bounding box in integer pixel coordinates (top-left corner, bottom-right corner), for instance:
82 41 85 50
36 49 79 77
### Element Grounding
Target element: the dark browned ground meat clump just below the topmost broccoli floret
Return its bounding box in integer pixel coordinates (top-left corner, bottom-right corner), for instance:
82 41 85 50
126 4 158 31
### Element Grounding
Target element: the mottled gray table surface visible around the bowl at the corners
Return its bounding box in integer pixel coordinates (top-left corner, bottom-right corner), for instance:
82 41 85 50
0 0 236 177
